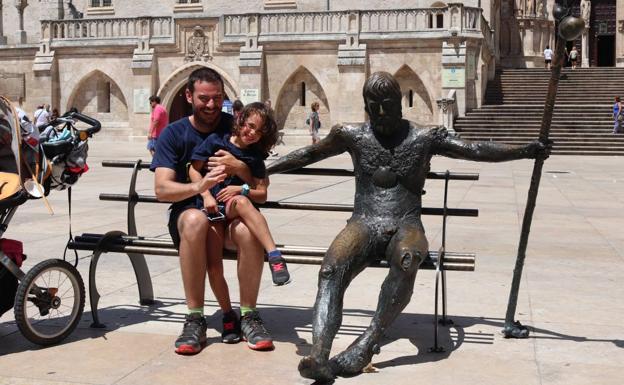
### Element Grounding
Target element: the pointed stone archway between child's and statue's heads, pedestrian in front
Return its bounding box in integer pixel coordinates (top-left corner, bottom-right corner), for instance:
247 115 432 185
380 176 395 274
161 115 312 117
275 67 331 130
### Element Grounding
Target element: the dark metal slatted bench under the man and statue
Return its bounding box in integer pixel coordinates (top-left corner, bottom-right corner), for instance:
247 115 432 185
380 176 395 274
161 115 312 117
69 160 479 352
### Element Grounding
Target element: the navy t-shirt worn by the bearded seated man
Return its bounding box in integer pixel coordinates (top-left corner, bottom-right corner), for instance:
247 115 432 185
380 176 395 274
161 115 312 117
150 112 233 209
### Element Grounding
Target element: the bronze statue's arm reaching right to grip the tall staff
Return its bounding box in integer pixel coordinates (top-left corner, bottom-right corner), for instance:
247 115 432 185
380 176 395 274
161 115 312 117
434 129 552 162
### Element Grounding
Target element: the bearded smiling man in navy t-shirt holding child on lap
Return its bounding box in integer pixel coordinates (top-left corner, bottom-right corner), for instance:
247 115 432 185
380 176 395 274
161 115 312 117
151 68 273 354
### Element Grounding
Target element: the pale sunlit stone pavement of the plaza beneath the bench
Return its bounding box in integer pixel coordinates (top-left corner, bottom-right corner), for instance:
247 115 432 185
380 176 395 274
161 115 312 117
0 138 624 385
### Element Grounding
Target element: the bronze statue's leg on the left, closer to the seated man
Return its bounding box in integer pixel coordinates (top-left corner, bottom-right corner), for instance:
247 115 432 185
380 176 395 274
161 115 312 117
299 220 372 381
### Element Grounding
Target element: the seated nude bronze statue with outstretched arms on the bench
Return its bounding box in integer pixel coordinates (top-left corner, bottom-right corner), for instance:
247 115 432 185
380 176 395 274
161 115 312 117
268 72 548 381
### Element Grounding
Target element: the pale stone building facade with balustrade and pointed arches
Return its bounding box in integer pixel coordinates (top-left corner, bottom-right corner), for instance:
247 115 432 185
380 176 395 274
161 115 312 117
0 0 624 140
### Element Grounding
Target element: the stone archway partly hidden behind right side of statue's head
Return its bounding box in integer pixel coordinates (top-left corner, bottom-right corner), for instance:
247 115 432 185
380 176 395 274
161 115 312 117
394 65 434 124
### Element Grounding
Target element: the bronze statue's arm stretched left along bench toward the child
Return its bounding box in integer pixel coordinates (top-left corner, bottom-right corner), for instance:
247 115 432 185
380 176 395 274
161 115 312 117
267 125 347 174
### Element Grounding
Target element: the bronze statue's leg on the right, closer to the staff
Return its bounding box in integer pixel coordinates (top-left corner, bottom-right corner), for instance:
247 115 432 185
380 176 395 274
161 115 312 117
330 224 428 375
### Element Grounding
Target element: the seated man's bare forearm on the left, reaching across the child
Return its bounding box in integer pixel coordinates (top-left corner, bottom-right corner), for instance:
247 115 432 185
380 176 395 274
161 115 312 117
154 167 227 202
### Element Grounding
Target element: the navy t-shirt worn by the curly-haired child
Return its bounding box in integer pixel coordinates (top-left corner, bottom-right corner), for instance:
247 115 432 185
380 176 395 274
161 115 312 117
191 133 266 201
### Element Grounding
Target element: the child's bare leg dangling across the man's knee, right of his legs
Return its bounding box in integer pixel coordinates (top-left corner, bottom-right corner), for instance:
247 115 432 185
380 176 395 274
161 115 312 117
225 195 276 253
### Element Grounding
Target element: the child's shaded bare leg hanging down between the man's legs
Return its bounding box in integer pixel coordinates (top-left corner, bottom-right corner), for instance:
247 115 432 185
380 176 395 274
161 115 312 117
206 223 232 313
